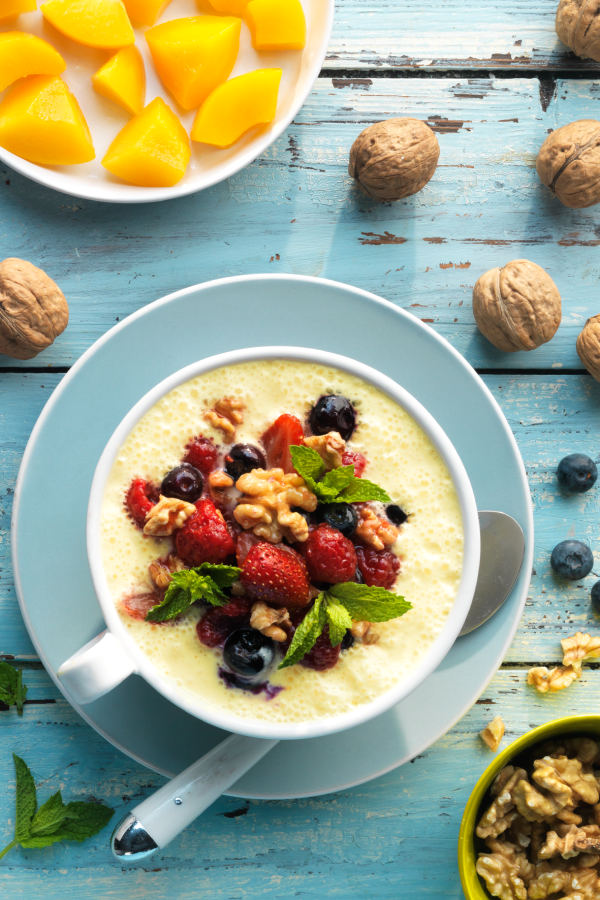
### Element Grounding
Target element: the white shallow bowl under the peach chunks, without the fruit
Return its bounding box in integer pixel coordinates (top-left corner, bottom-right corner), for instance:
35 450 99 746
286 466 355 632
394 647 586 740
0 0 334 203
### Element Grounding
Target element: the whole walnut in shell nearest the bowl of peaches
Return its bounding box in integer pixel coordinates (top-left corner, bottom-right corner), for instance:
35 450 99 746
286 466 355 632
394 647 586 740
348 119 440 203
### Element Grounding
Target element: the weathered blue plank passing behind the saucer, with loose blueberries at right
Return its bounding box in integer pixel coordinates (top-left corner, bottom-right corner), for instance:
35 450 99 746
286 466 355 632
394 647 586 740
0 373 600 663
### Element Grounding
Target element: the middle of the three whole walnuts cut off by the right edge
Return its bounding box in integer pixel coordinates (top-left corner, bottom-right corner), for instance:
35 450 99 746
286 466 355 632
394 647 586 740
535 119 600 209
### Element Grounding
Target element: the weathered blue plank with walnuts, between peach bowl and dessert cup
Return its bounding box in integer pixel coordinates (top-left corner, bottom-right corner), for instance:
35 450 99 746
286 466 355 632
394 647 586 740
0 78 600 369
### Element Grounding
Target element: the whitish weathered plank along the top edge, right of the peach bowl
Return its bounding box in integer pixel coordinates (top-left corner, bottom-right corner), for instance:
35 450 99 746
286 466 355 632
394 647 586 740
325 0 598 72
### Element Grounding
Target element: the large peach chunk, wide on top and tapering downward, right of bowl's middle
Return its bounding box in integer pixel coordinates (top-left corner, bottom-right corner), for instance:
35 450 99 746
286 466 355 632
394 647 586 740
146 16 242 109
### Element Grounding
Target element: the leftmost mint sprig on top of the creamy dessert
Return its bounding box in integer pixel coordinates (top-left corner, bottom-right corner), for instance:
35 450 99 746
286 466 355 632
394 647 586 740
146 563 242 622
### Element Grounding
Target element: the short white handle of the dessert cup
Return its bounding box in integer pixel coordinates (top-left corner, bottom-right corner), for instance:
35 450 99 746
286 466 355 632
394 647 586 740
57 631 137 704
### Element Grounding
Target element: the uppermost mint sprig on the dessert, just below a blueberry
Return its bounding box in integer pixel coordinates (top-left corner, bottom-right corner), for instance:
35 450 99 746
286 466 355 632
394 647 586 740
290 444 391 503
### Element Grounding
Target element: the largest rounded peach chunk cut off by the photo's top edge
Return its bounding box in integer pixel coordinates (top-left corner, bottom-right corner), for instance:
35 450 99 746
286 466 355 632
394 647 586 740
40 0 135 50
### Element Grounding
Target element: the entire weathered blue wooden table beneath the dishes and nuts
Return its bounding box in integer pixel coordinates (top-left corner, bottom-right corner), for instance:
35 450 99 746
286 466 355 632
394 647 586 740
0 0 600 900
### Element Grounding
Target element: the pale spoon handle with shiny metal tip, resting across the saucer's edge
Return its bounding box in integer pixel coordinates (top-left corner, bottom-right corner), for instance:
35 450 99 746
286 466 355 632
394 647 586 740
111 734 278 861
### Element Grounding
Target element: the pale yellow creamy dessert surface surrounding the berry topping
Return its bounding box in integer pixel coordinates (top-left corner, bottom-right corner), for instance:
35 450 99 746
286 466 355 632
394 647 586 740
101 360 463 722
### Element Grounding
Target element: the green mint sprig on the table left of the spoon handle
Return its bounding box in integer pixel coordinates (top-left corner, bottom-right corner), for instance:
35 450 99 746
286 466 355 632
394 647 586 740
0 753 114 859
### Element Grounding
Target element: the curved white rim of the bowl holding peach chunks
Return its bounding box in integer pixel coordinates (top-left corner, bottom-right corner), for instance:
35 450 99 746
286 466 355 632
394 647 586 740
0 0 335 203
